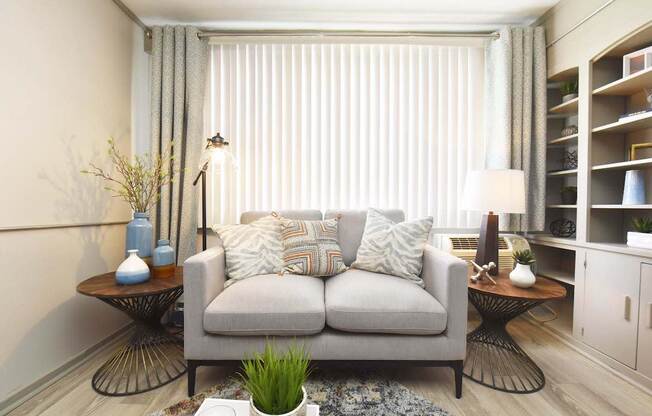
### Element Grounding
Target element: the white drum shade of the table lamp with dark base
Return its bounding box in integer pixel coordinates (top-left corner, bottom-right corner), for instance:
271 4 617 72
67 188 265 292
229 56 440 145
462 169 525 214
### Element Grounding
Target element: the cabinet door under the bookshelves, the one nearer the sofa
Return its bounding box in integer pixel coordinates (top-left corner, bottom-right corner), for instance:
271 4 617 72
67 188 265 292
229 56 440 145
583 250 641 368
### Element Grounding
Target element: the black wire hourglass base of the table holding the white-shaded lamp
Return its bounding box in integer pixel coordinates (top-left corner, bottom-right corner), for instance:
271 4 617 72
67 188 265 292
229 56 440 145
464 290 546 393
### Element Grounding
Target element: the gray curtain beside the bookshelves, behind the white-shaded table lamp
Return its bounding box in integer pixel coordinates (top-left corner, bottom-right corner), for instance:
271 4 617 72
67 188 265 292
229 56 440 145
485 27 547 231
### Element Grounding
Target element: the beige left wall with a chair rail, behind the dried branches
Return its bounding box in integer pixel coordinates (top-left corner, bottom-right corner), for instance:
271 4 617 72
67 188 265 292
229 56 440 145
0 0 147 402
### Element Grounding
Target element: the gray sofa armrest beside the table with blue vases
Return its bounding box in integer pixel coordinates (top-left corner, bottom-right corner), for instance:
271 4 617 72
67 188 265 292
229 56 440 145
183 245 226 345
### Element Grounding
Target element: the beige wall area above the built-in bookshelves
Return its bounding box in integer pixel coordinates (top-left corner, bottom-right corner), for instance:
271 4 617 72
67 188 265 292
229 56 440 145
539 0 652 75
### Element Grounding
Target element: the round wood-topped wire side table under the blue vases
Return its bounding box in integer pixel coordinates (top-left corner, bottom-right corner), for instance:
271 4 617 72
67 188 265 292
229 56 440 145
77 267 186 396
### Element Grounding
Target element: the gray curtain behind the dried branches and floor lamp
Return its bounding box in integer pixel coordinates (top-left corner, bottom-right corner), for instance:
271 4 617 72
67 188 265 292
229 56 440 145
151 26 208 264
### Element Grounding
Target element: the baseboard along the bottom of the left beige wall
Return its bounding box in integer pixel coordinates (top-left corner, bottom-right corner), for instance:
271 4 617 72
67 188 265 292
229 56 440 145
0 323 133 416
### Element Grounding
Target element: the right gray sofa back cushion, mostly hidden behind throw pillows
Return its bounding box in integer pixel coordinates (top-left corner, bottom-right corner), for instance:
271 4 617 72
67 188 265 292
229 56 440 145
324 209 405 266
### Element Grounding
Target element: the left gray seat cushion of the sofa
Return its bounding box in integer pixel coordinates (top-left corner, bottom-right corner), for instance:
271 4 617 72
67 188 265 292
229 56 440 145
204 274 326 335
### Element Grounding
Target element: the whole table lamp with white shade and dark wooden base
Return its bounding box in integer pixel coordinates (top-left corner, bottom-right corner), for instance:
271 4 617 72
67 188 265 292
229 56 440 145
462 169 525 276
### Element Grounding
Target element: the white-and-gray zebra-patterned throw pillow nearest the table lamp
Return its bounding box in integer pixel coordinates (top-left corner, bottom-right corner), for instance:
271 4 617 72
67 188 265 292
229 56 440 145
351 208 432 287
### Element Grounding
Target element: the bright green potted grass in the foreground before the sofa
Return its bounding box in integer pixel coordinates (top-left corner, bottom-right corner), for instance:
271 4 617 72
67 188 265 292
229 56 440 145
240 343 311 416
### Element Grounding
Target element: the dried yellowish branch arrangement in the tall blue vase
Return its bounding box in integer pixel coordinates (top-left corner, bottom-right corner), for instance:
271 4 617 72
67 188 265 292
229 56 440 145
81 139 177 212
